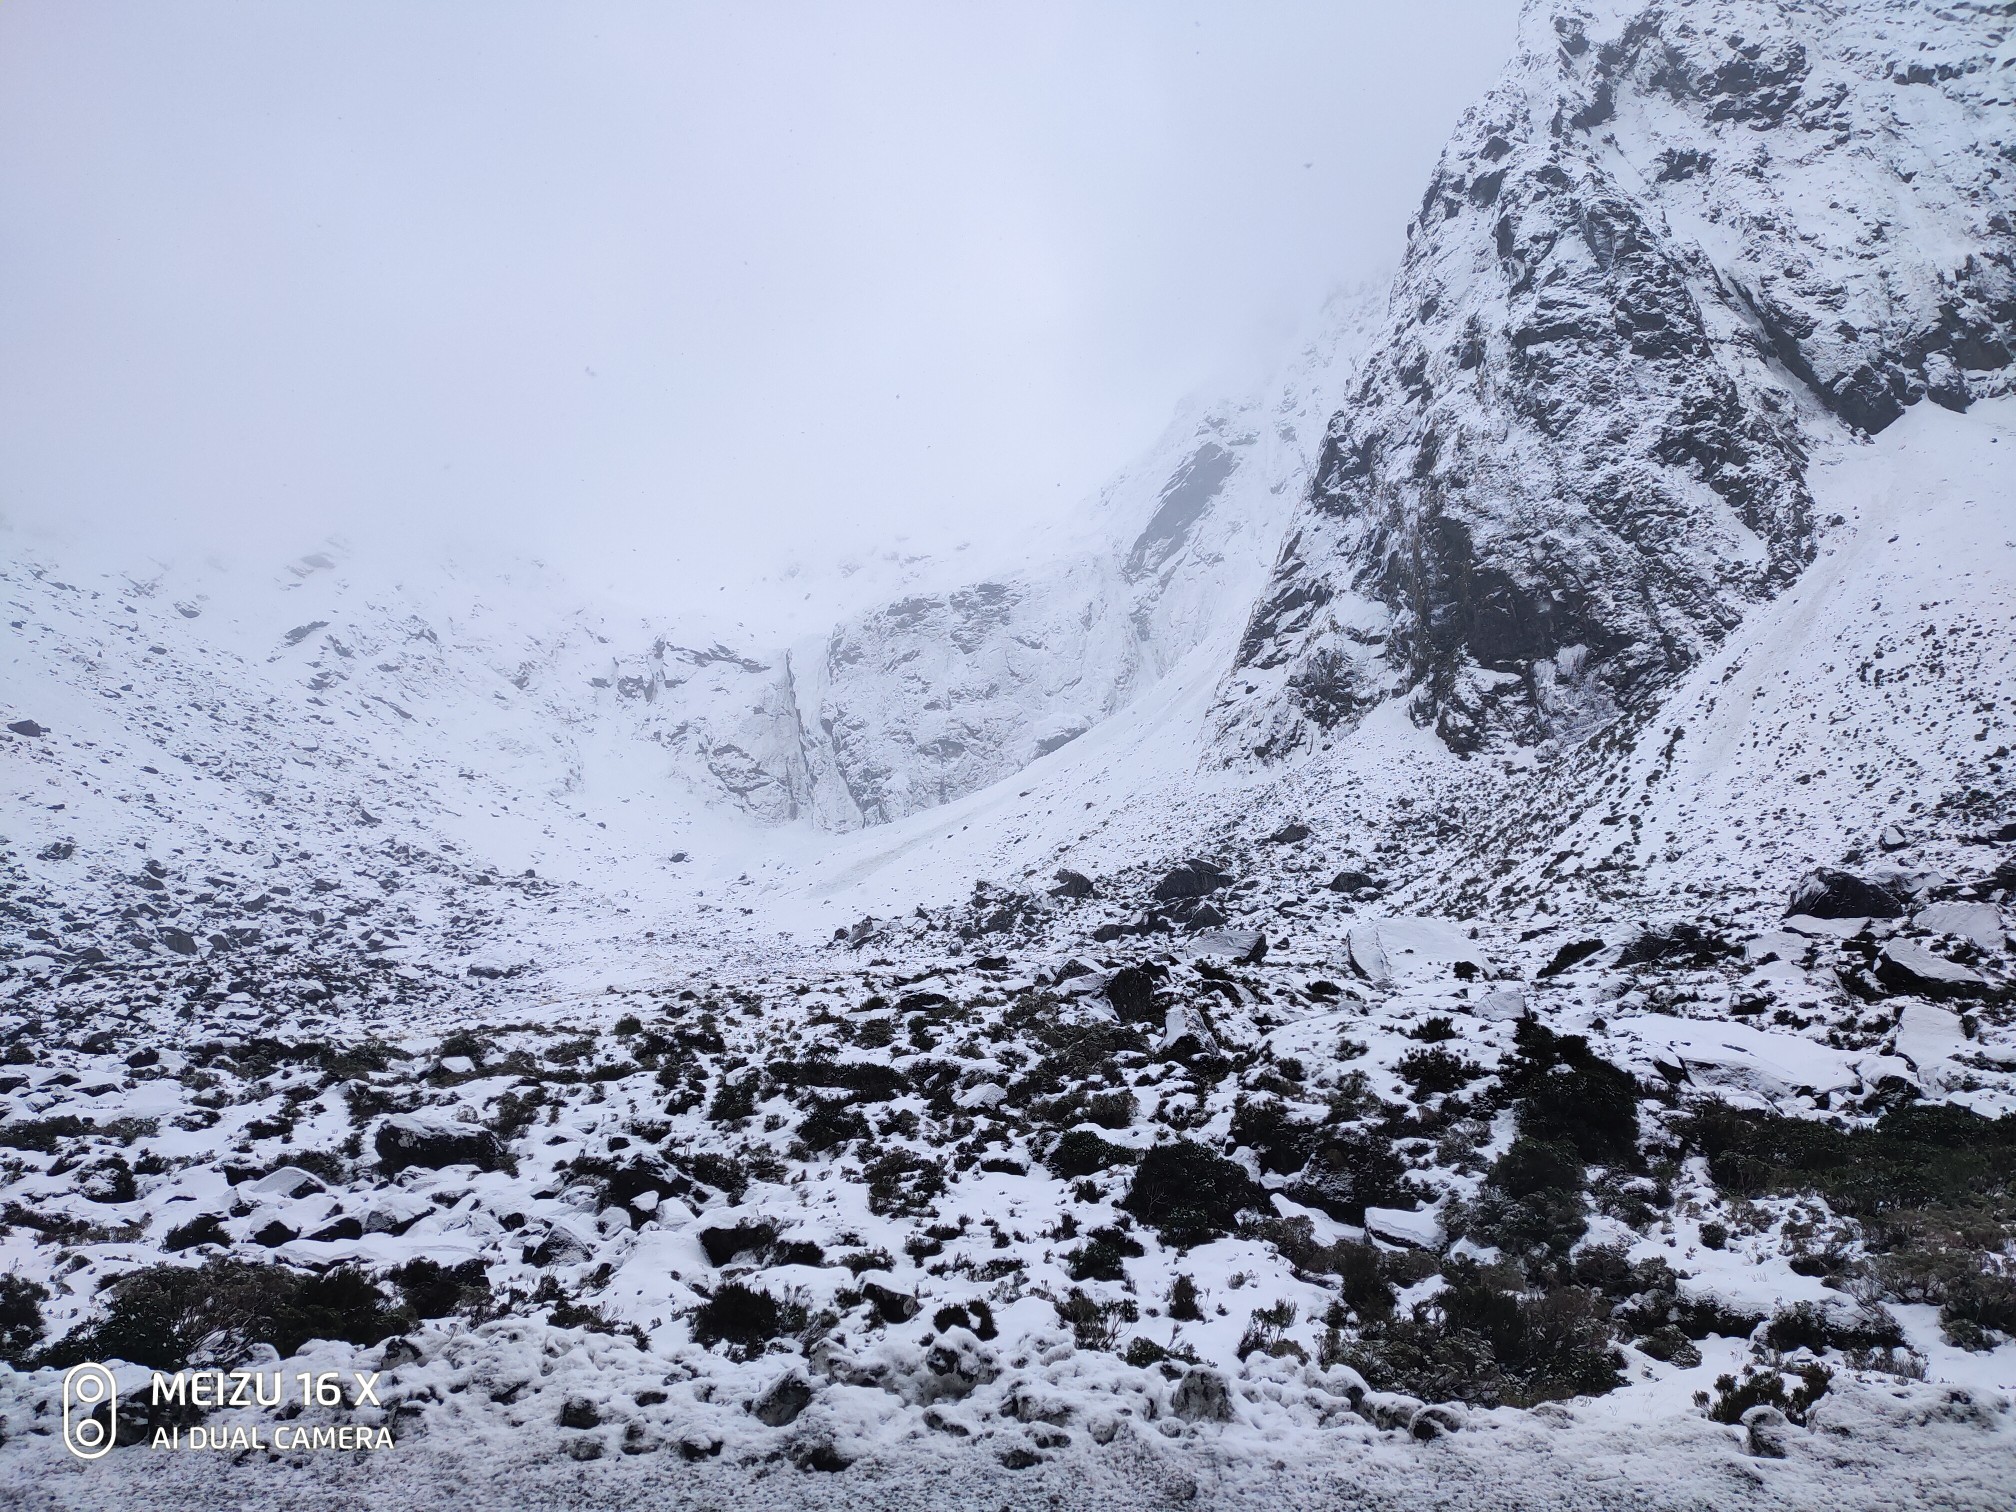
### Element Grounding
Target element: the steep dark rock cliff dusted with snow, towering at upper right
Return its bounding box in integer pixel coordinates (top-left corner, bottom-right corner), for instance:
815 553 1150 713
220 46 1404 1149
1214 2 2016 760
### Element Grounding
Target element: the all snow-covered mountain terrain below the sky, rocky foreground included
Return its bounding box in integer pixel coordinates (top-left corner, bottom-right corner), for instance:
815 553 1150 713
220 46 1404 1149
0 0 2016 1508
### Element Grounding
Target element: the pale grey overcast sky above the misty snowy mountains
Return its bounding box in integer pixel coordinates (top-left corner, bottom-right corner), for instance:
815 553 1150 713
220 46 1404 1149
0 0 1516 608
